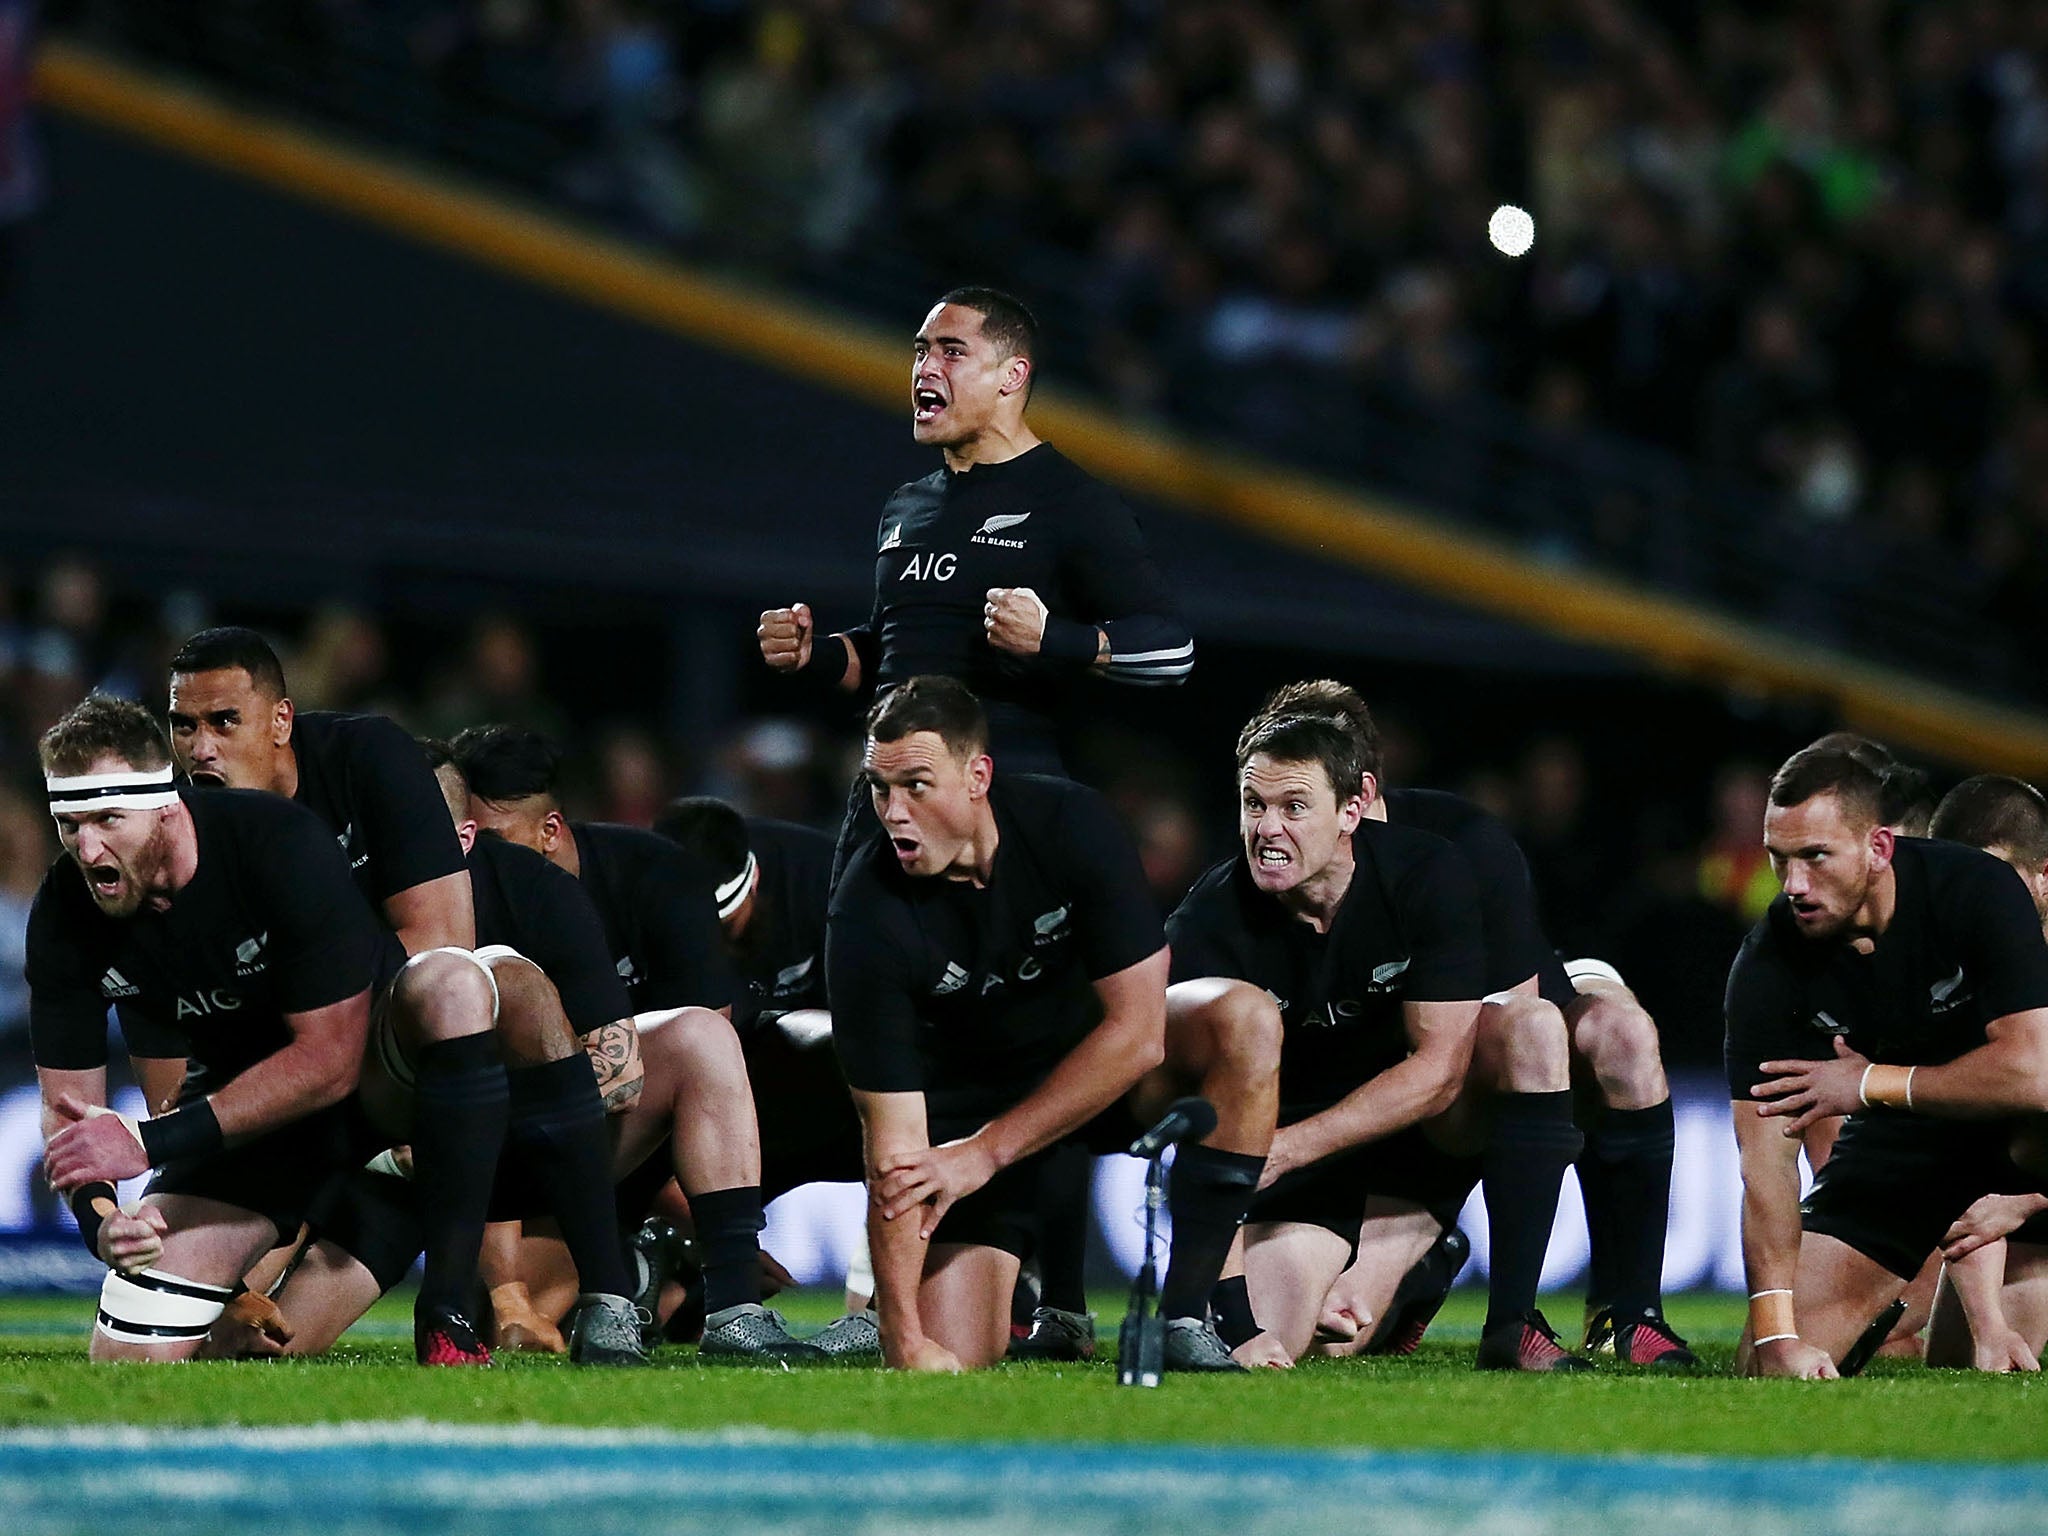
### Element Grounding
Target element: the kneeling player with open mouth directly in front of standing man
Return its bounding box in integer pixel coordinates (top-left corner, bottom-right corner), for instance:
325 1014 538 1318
825 676 1278 1370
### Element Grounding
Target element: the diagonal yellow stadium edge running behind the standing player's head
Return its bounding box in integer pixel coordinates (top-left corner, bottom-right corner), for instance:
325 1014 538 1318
37 39 2048 776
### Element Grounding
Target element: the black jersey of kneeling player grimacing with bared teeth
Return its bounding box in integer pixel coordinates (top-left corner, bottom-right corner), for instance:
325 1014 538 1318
1167 821 1487 1124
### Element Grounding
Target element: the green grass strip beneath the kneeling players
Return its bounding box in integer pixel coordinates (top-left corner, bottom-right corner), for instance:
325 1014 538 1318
0 1292 2048 1462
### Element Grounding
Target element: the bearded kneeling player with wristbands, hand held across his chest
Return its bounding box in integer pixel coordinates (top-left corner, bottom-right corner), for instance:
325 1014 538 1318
1726 745 2048 1378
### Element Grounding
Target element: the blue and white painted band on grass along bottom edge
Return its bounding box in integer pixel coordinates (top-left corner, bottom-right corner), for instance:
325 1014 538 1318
0 1423 2048 1536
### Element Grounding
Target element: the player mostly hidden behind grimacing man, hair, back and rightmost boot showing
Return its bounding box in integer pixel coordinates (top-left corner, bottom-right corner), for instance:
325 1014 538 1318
1260 678 1698 1366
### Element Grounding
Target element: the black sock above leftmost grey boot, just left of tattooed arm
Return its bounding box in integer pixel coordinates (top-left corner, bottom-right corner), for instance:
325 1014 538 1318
506 1051 633 1296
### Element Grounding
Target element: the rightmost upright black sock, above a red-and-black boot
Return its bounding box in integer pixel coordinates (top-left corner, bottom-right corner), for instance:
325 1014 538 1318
1579 1100 1673 1321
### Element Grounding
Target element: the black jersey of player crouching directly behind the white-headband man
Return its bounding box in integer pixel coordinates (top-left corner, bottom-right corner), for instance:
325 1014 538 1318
291 709 463 920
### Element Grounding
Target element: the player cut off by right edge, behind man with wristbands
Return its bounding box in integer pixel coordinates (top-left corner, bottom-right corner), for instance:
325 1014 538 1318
1927 774 2048 1370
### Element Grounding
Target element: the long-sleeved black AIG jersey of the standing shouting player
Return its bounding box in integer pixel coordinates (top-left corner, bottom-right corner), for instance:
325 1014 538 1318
848 442 1194 756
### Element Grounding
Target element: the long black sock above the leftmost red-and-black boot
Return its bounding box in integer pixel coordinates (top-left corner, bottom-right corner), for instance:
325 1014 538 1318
412 1032 508 1317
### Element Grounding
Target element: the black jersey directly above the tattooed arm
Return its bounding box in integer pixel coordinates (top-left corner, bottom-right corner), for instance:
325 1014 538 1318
471 835 633 1034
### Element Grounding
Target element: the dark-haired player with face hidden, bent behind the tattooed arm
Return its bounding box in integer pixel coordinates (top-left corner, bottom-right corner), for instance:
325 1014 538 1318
442 725 823 1358
